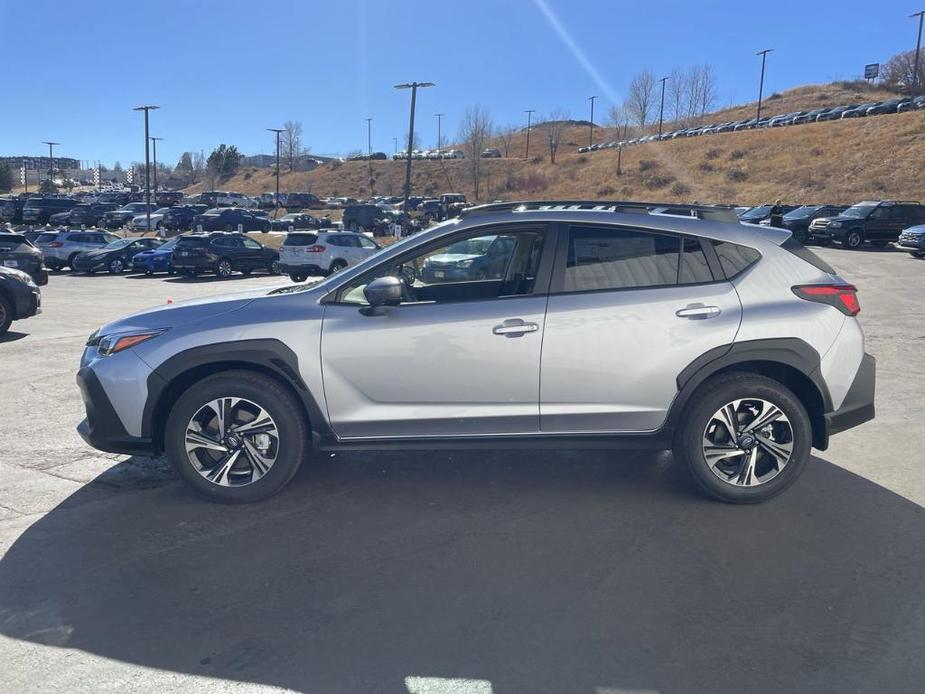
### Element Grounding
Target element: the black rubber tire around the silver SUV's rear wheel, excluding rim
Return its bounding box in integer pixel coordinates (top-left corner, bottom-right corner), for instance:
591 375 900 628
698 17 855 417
674 372 812 504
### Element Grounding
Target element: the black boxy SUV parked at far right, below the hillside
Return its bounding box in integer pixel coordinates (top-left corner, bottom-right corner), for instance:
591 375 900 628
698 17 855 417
810 200 925 249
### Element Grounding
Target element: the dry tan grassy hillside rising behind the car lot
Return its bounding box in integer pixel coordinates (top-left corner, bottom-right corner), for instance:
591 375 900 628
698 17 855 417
193 83 925 204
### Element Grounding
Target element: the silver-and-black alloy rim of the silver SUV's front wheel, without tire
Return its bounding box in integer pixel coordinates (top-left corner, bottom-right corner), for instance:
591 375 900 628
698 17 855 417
184 397 280 487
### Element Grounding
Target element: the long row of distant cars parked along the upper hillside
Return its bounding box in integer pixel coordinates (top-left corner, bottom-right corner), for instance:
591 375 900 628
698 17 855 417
578 95 925 153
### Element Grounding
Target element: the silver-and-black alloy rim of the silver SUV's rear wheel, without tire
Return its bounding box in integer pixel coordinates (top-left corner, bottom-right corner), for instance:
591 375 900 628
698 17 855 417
703 398 794 487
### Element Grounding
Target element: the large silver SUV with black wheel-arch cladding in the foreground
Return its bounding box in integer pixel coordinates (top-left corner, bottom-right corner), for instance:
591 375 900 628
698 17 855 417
77 203 874 503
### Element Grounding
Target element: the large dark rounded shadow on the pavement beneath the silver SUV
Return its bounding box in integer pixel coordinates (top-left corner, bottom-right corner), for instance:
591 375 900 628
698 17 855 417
0 451 925 694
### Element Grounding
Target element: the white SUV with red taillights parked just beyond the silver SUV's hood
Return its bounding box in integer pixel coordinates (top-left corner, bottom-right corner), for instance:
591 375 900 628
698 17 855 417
279 231 380 282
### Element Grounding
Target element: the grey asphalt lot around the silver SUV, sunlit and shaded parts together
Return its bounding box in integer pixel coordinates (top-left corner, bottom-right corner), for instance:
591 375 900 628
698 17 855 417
0 249 925 694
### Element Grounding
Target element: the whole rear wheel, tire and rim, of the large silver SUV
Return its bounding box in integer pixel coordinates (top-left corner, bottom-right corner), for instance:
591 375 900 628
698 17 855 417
675 373 812 504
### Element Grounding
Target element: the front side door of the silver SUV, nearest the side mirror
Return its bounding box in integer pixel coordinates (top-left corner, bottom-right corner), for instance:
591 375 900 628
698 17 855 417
321 225 554 439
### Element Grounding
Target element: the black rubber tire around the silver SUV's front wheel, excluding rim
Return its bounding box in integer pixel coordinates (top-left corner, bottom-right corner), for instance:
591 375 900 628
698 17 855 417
164 371 309 504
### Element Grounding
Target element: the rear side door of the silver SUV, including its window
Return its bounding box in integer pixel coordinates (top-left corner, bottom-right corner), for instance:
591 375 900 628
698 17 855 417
540 224 742 434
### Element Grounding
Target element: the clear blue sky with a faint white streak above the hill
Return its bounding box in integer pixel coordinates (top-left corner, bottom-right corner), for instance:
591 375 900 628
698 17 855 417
0 0 908 165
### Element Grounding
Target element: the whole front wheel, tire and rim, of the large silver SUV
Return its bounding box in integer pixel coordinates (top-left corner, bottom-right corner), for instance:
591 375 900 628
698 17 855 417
164 371 309 504
